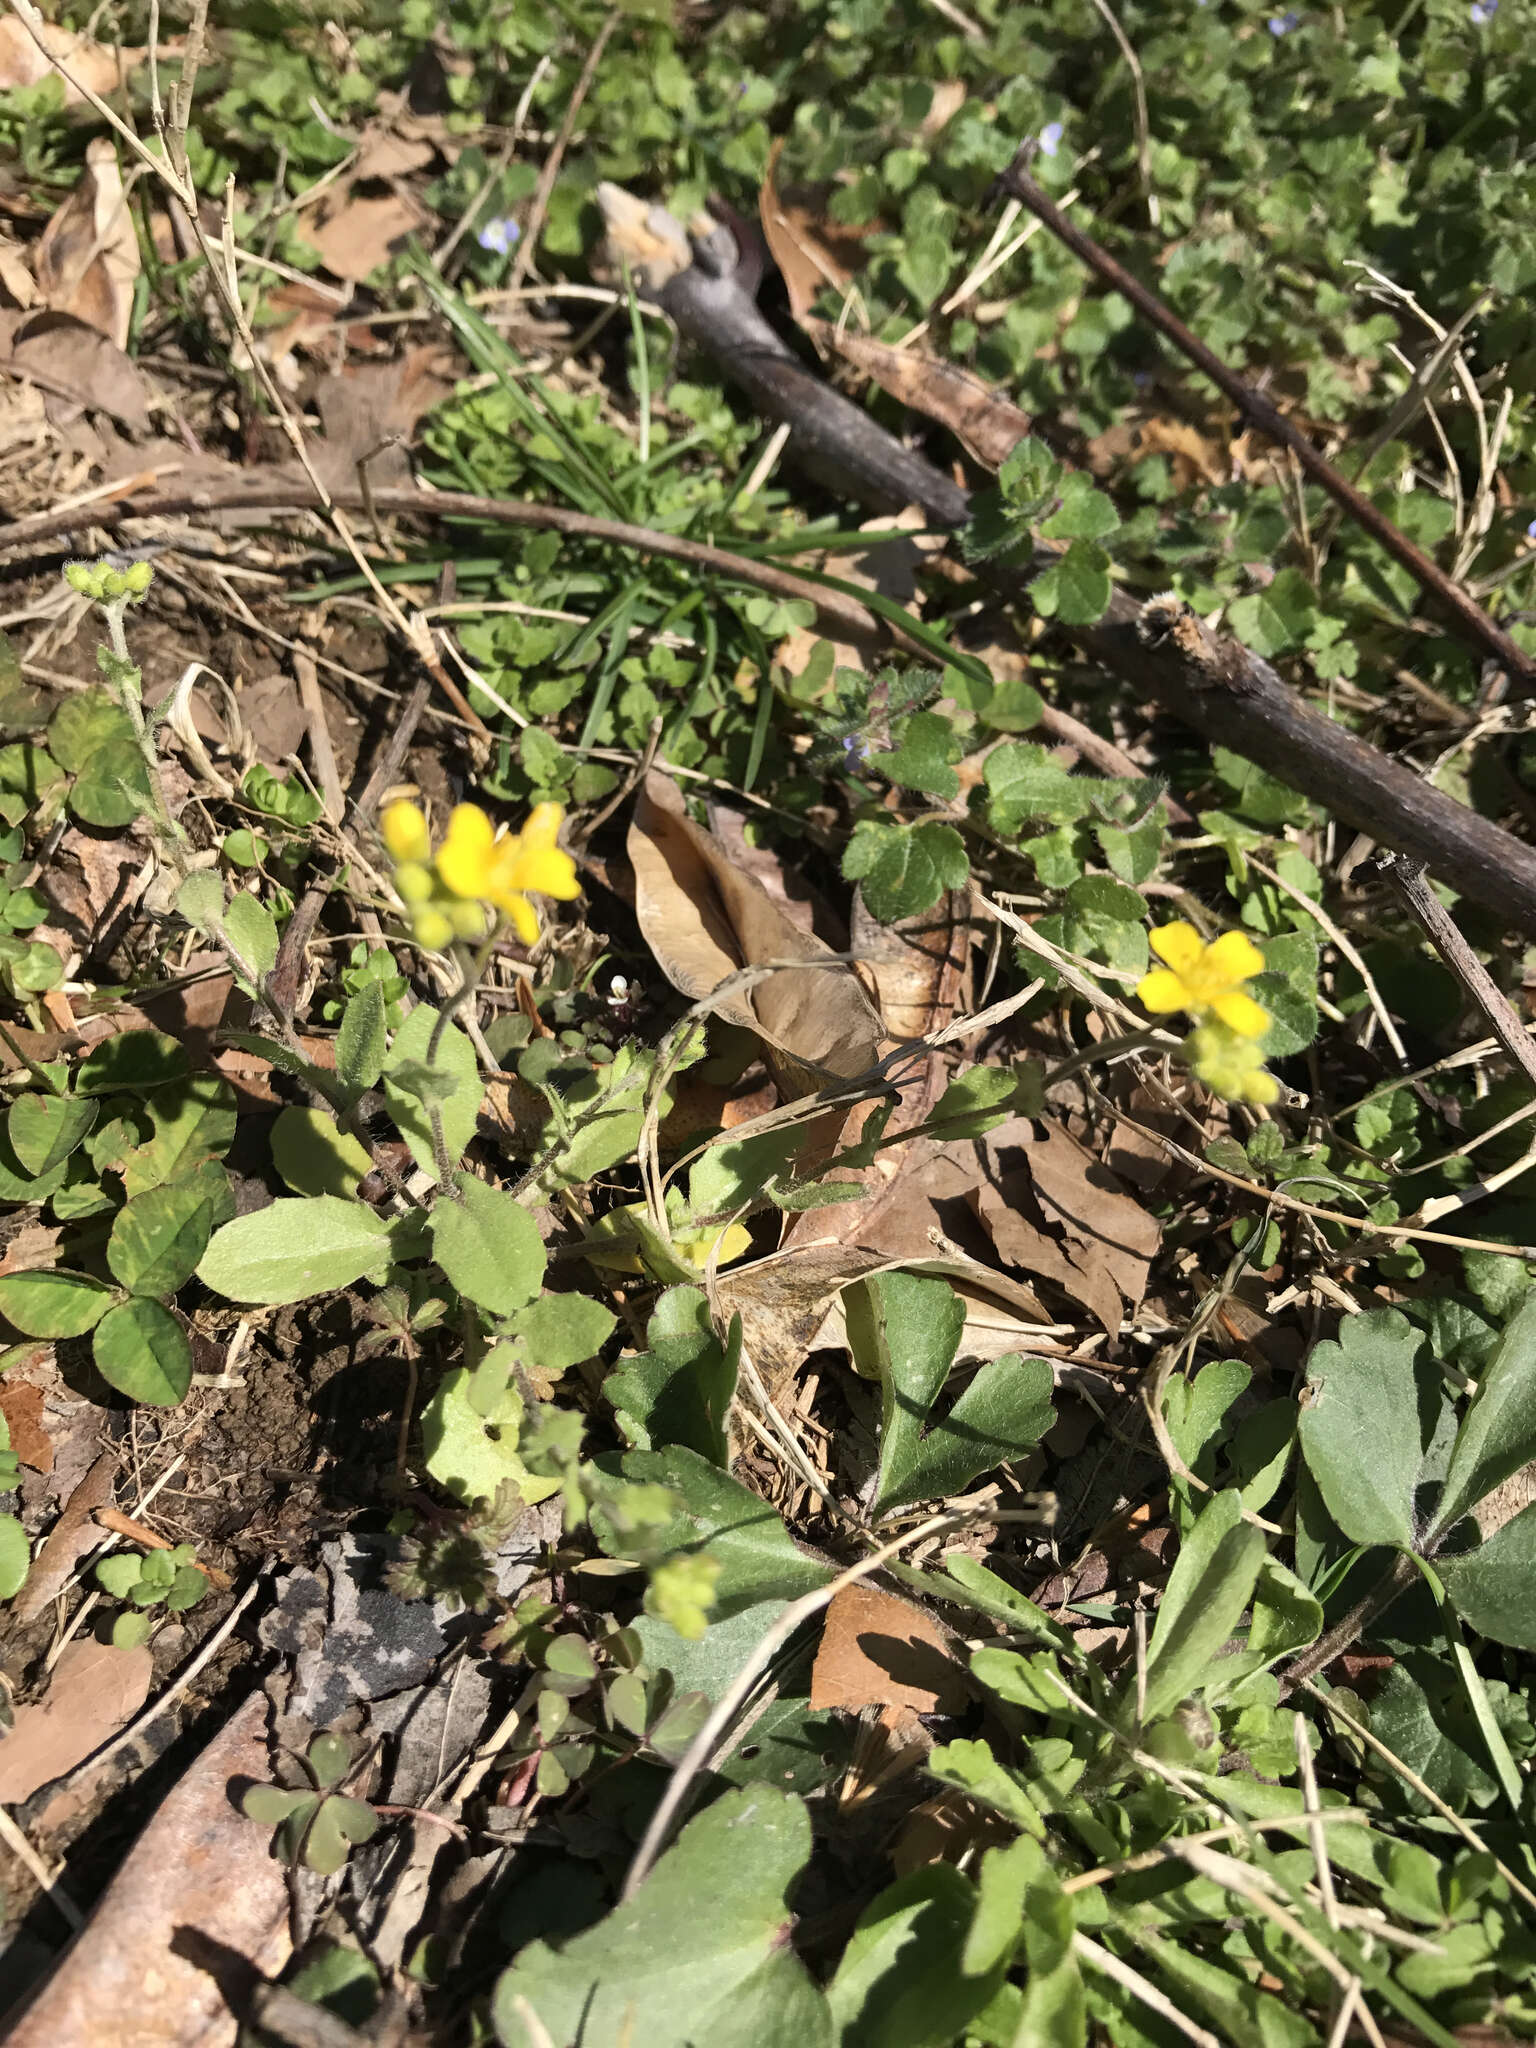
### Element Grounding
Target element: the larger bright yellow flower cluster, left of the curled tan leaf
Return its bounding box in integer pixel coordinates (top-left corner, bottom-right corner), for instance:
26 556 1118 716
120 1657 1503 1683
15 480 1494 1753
379 803 582 952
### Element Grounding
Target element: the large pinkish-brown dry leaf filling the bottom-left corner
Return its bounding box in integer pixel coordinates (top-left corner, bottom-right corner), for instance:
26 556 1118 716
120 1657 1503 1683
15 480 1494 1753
0 1687 289 2048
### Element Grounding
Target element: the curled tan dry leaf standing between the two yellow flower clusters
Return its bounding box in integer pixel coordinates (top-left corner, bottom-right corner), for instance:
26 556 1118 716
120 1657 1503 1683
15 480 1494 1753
629 770 883 1096
